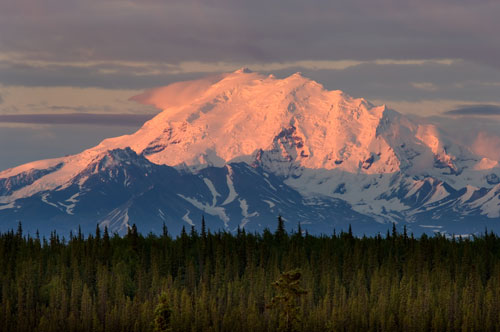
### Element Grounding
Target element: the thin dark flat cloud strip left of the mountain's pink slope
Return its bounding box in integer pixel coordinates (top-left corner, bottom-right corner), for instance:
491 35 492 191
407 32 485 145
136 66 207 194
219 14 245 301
0 113 155 127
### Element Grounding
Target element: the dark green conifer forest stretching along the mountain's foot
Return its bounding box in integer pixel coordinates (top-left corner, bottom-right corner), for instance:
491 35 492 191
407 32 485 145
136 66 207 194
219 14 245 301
0 219 500 332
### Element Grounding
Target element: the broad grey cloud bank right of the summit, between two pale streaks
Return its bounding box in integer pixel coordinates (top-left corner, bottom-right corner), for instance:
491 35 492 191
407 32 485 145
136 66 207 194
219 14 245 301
273 61 500 103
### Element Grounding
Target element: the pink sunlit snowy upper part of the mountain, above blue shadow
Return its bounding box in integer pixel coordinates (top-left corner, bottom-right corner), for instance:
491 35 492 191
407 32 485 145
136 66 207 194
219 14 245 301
116 68 496 179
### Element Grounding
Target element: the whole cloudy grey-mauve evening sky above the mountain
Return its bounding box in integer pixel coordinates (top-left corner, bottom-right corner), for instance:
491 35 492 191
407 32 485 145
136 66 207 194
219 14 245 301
0 0 500 170
